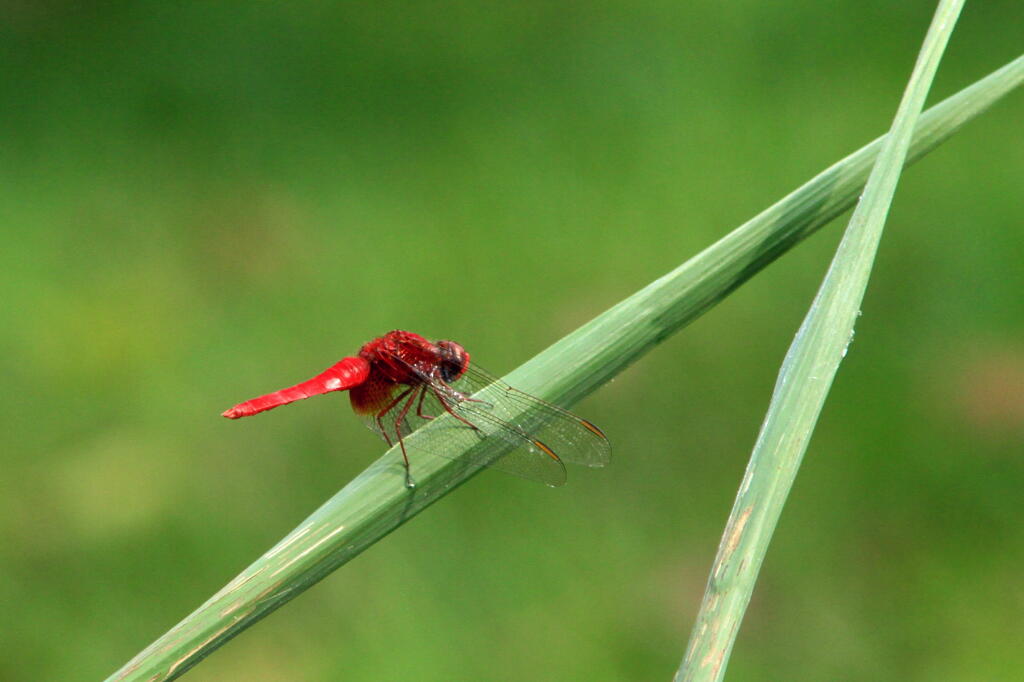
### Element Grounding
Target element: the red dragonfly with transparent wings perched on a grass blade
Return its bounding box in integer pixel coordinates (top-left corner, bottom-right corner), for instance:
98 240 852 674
223 331 611 487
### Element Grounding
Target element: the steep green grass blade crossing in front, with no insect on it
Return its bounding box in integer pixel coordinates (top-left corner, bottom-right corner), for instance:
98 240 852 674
676 0 964 682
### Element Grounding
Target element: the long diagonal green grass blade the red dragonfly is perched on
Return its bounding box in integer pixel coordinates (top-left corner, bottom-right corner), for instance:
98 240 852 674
111 51 1024 680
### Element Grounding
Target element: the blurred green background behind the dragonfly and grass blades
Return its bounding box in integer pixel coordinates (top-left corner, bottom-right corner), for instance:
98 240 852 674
0 0 1024 681
